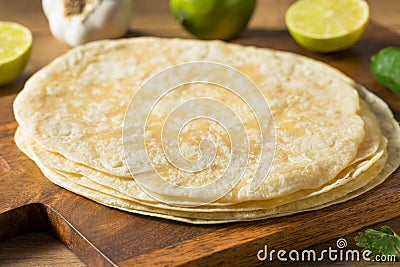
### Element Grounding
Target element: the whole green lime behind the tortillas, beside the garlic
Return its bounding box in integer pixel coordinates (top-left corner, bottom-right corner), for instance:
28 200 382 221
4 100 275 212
170 0 257 40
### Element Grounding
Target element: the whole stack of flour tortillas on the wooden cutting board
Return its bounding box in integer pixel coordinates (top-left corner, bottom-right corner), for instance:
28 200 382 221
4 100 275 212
14 37 400 223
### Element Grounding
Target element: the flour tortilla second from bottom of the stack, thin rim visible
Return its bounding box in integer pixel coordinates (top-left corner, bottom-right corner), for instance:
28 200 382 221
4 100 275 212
16 129 387 216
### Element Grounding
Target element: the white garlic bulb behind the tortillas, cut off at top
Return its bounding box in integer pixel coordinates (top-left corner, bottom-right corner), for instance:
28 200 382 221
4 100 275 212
42 0 131 46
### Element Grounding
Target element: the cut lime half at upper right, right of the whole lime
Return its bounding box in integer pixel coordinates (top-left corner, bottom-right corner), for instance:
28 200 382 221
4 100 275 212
285 0 369 52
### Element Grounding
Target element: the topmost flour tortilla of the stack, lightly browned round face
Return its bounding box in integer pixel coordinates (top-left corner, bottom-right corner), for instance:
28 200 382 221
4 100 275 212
14 37 365 203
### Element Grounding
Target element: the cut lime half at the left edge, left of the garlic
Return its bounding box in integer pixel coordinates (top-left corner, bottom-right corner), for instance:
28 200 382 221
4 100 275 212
0 21 32 86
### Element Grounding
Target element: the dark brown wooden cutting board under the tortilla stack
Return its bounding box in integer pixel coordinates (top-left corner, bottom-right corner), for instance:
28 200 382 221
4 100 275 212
0 23 400 266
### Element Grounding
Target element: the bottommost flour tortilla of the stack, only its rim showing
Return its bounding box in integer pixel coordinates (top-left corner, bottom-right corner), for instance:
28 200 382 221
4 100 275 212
12 95 400 224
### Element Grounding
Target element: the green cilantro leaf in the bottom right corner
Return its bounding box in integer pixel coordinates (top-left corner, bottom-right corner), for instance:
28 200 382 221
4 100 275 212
354 226 400 261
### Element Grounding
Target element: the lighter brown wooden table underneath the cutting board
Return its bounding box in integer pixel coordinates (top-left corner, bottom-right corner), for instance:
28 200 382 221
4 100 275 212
0 0 400 266
